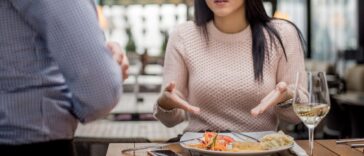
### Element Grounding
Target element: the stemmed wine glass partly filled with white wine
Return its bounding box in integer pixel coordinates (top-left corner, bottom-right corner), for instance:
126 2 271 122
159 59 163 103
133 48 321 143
293 72 330 155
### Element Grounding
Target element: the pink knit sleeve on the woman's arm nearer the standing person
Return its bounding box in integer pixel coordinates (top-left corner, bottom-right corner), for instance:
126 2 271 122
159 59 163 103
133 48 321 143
154 25 188 127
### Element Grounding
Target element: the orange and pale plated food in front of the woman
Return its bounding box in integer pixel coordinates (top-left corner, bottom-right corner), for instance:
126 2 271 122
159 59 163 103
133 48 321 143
187 132 294 152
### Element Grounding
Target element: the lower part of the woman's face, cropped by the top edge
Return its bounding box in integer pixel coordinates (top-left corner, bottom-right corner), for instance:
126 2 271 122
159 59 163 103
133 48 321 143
205 0 245 17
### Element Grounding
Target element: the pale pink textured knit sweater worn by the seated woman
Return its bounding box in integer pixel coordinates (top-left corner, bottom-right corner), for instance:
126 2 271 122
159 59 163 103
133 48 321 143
154 20 305 131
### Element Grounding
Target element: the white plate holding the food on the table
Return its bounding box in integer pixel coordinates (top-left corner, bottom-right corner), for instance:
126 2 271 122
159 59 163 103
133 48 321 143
181 131 293 156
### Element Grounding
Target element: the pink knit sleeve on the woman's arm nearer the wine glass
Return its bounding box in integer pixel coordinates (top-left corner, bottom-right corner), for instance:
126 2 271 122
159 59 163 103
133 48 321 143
276 21 305 123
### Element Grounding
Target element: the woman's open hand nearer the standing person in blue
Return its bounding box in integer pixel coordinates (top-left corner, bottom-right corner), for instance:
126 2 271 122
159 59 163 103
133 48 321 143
158 82 200 114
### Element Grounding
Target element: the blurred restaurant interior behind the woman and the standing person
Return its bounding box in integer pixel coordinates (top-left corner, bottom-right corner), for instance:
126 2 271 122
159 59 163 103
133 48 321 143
75 0 364 156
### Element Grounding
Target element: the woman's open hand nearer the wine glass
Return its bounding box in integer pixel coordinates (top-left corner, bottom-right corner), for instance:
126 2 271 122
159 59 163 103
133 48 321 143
250 82 292 116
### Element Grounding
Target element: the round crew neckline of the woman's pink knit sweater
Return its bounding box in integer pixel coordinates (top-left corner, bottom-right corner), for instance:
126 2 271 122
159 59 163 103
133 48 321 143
207 20 252 42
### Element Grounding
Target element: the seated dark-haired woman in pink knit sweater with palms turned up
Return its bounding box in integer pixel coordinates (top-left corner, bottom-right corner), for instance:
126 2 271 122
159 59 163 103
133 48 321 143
154 0 305 131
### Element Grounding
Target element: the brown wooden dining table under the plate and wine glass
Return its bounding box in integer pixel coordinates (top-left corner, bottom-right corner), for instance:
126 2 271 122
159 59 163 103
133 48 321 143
106 140 364 156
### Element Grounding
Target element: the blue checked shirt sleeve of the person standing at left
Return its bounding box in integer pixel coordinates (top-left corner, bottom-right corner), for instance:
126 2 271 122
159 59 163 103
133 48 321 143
9 0 122 122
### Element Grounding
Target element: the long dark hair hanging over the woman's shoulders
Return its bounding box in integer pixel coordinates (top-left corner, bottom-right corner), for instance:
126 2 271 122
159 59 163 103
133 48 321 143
195 0 305 82
